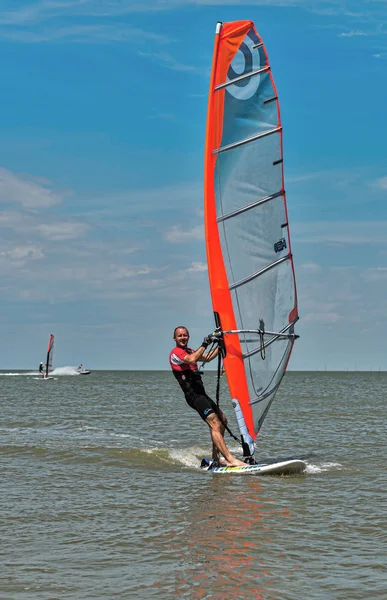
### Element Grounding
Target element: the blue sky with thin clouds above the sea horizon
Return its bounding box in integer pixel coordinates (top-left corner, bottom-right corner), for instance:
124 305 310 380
0 0 387 370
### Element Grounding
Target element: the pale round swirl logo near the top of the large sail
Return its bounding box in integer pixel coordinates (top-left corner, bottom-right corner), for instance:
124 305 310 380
226 31 261 100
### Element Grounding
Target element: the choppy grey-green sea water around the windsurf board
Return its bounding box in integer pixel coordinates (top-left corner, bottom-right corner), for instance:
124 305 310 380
0 370 387 600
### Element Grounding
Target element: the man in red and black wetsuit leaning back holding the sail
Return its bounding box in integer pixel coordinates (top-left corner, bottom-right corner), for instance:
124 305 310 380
169 326 246 467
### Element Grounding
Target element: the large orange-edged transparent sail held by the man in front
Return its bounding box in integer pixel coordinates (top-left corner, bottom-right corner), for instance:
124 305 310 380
205 21 298 453
